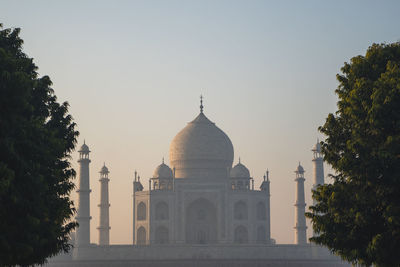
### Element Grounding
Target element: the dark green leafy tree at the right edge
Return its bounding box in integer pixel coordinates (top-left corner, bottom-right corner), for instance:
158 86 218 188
306 43 400 267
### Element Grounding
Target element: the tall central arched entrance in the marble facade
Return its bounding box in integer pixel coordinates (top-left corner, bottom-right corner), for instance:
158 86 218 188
186 198 218 244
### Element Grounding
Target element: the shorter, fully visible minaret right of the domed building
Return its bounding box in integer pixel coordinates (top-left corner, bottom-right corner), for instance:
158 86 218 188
294 162 307 245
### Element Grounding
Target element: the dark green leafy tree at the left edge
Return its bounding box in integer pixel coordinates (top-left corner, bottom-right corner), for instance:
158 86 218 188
0 24 78 266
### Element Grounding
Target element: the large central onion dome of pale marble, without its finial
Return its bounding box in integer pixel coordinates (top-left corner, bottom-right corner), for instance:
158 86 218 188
169 112 233 178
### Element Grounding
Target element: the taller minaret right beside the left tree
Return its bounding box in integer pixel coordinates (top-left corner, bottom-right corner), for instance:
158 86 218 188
76 142 92 246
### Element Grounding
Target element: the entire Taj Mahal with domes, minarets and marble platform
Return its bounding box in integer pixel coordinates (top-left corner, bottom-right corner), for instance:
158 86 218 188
48 100 350 267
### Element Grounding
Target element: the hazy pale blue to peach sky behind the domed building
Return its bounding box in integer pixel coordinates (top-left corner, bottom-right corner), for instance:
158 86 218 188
0 0 400 244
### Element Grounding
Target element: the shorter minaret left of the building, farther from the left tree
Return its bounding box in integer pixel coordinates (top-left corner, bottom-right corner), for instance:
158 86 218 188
97 163 111 245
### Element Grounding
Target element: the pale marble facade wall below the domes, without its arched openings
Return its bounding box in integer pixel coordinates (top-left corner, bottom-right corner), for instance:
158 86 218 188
135 179 270 244
